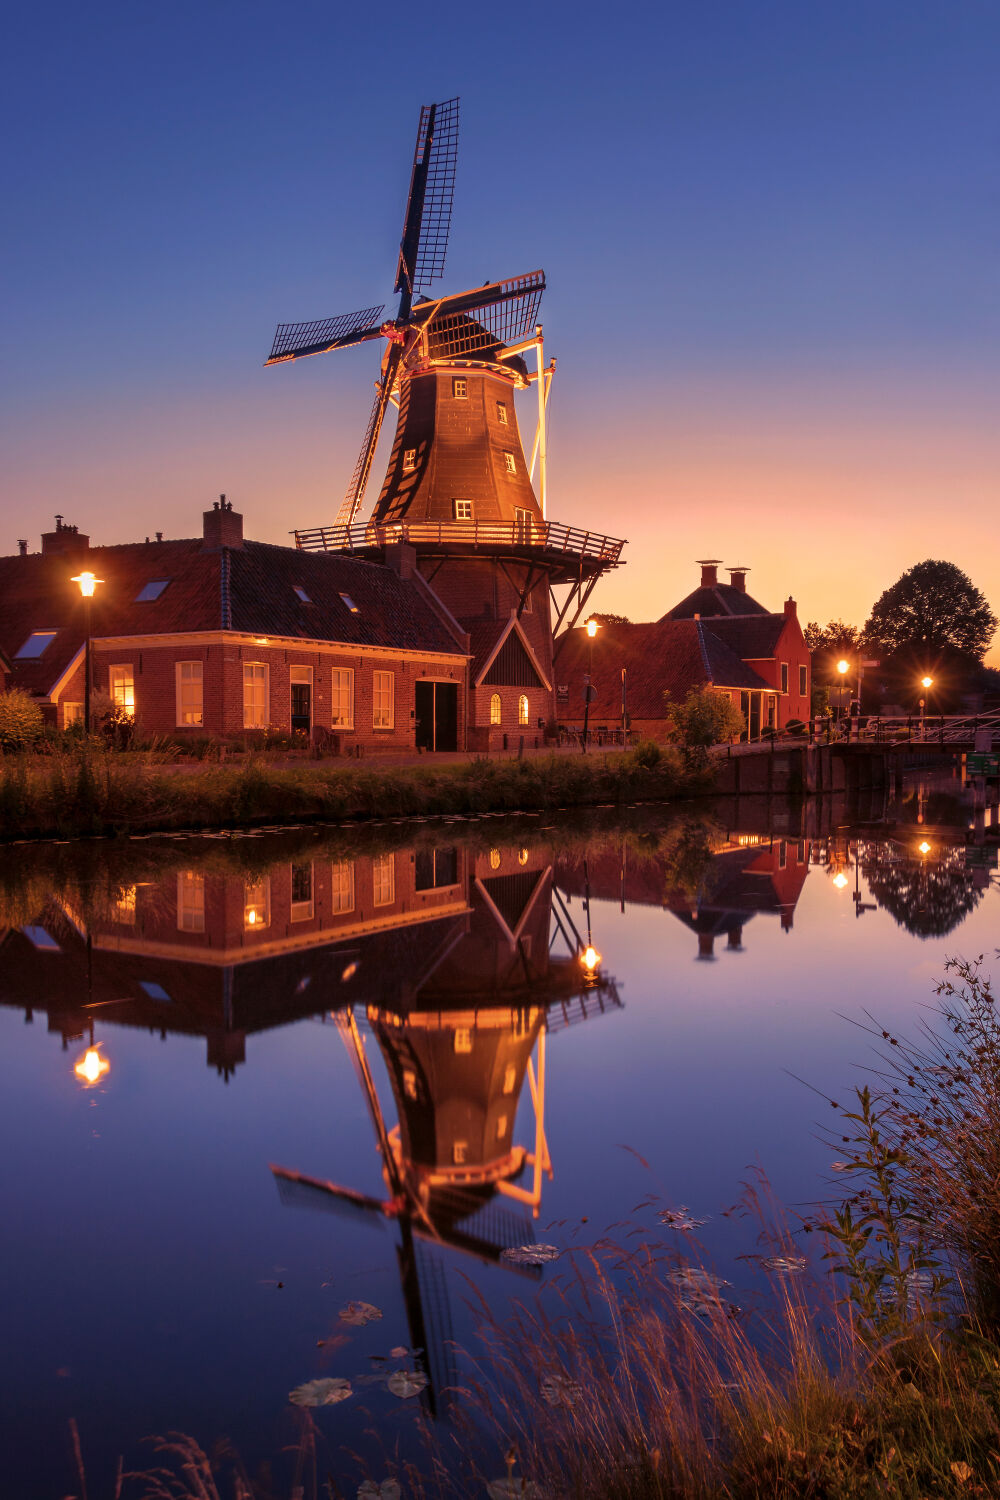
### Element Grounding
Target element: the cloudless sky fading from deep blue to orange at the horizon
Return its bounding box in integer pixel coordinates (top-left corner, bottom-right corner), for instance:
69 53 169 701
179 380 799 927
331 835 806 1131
0 0 1000 662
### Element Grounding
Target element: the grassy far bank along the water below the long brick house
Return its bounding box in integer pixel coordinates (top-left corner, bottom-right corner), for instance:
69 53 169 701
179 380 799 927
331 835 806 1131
0 746 712 840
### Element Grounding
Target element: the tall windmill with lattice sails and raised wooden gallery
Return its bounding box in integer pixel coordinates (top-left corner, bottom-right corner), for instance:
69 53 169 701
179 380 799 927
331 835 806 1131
267 99 624 749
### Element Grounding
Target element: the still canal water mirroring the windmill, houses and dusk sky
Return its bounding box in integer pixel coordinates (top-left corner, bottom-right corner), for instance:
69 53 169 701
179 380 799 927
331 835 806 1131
0 779 1000 1500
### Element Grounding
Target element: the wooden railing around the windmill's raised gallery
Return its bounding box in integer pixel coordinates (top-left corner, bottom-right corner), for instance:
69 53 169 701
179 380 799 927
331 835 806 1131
292 518 625 567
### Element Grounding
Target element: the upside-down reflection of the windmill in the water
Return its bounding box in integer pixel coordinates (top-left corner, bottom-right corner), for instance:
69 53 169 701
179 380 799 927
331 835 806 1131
273 851 621 1410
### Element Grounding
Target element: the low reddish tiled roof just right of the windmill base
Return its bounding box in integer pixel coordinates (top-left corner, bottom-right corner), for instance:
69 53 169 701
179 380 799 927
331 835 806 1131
555 620 766 723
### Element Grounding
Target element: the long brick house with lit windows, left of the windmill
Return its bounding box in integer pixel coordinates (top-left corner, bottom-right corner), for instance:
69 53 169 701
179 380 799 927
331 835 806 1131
0 497 469 752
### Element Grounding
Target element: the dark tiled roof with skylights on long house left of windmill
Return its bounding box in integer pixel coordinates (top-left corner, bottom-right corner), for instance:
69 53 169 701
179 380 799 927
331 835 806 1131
0 537 460 695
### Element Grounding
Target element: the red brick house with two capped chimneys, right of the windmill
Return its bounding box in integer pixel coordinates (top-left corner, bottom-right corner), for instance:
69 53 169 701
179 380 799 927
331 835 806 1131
556 561 811 740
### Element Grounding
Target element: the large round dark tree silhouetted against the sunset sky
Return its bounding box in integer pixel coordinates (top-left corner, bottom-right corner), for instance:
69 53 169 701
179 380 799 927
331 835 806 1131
865 558 999 662
